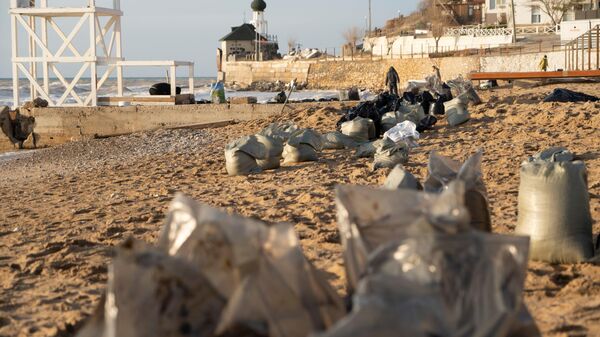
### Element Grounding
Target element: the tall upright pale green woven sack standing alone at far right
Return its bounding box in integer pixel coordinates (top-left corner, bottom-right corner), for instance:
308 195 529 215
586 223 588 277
515 156 594 263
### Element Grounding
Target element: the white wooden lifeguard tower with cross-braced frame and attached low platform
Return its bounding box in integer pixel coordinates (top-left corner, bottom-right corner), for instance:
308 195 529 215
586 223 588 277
10 0 195 107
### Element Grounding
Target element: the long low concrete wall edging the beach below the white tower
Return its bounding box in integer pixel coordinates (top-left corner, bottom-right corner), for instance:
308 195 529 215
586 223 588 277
0 103 350 151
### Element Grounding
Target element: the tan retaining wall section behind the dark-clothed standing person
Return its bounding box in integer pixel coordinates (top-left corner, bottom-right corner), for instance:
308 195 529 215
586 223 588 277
308 57 479 89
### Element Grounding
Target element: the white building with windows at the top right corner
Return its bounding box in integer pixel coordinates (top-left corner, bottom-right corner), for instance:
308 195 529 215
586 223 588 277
483 0 598 26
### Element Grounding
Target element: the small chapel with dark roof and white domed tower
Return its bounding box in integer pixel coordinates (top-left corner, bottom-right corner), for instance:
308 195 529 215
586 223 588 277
220 0 280 61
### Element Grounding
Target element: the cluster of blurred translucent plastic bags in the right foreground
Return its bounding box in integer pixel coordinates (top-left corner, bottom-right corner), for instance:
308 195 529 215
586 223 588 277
316 181 540 337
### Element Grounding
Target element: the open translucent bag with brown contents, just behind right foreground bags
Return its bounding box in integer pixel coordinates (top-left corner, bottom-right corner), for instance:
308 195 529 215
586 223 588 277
424 150 492 232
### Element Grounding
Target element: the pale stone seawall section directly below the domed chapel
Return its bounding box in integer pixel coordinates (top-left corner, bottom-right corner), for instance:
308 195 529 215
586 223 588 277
224 60 315 85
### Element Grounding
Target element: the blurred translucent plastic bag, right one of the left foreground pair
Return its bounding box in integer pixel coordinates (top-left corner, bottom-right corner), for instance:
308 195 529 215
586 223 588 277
159 195 345 337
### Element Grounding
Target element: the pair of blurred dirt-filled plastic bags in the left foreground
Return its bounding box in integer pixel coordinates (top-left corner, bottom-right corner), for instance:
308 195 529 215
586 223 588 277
77 195 346 337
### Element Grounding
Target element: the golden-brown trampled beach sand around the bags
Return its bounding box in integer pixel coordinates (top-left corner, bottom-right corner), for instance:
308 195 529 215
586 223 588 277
0 84 600 336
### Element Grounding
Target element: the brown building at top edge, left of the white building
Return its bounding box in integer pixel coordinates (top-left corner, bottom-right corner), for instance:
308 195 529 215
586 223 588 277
436 0 485 26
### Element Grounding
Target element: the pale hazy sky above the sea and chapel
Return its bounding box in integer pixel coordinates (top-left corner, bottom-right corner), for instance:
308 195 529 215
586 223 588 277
0 0 418 78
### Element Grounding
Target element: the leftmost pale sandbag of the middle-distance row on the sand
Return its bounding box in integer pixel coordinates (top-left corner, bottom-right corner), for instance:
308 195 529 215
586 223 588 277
225 136 267 176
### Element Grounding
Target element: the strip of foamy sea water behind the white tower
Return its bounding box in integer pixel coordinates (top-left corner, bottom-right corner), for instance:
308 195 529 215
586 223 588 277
0 77 338 106
